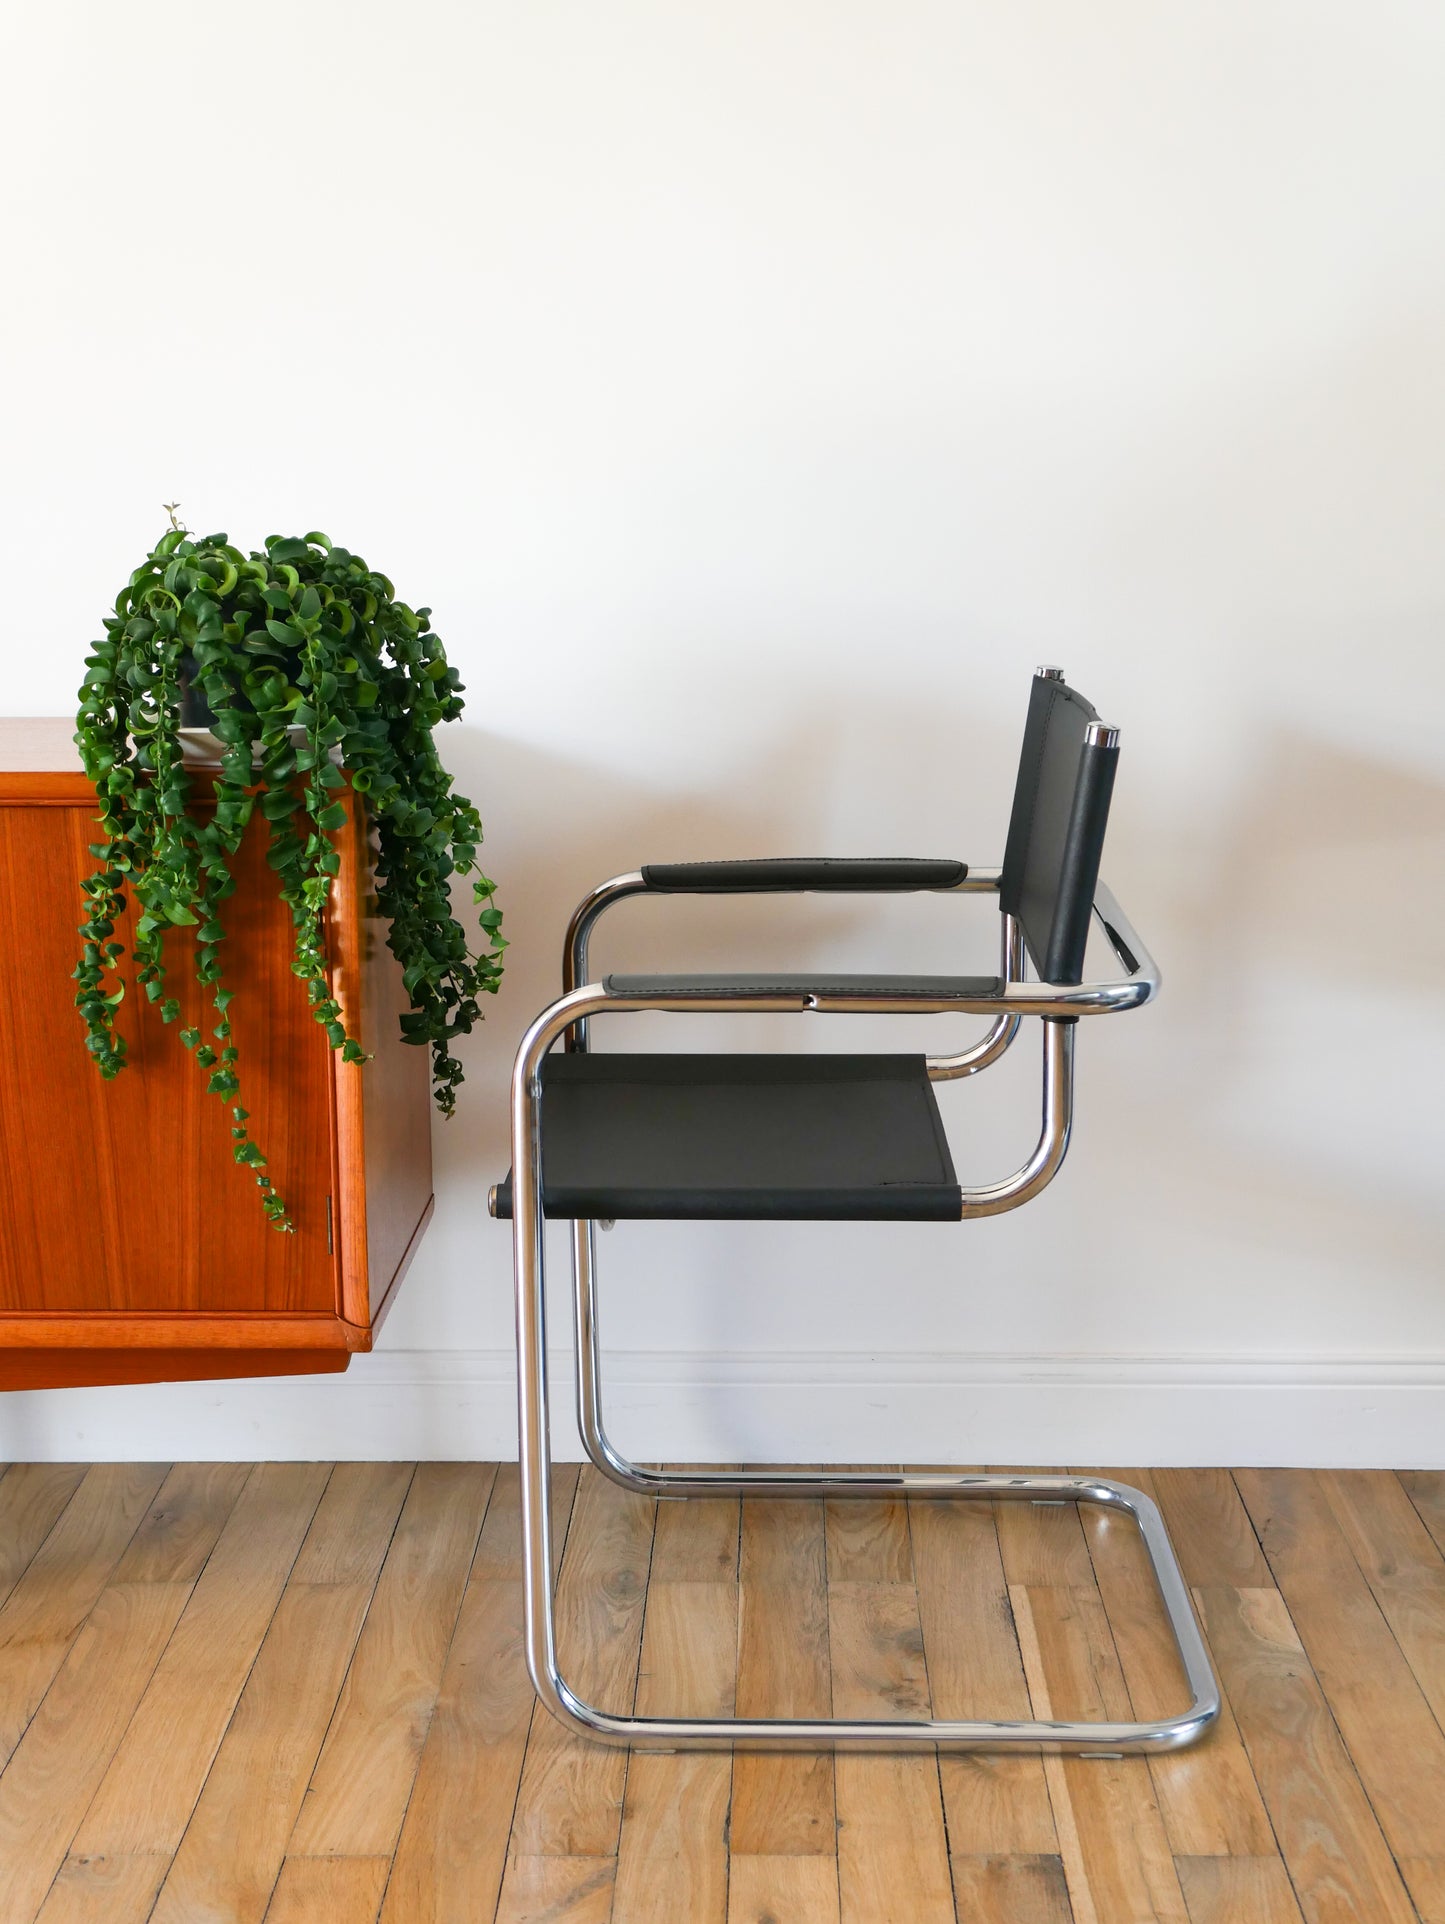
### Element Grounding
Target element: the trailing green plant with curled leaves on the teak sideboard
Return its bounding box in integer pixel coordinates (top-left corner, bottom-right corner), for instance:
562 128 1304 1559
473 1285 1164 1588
75 514 506 1229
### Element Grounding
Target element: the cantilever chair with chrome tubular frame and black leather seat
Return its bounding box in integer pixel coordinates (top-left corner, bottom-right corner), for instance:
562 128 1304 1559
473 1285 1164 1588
489 668 1220 1755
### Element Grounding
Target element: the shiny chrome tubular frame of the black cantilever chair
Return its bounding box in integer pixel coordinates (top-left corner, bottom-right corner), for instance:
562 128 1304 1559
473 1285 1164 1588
512 888 1220 1755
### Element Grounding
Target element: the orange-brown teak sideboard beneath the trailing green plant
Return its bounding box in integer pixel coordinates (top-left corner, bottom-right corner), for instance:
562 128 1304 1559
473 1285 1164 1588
0 722 431 1389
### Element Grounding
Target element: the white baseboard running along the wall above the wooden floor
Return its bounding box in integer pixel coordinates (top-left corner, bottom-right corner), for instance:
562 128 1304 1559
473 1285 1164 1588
0 1351 1445 1468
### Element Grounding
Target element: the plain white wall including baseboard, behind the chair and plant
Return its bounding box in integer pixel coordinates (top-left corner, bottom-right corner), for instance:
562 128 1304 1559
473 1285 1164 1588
0 0 1445 1464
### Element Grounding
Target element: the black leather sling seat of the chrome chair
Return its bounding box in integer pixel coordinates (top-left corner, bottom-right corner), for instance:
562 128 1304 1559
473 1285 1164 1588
496 1054 962 1222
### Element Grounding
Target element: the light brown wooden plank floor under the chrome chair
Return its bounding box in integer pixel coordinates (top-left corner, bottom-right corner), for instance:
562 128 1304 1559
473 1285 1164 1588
0 1464 1445 1924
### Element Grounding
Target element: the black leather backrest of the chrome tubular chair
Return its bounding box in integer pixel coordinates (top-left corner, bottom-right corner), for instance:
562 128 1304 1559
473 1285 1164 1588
999 675 1118 983
